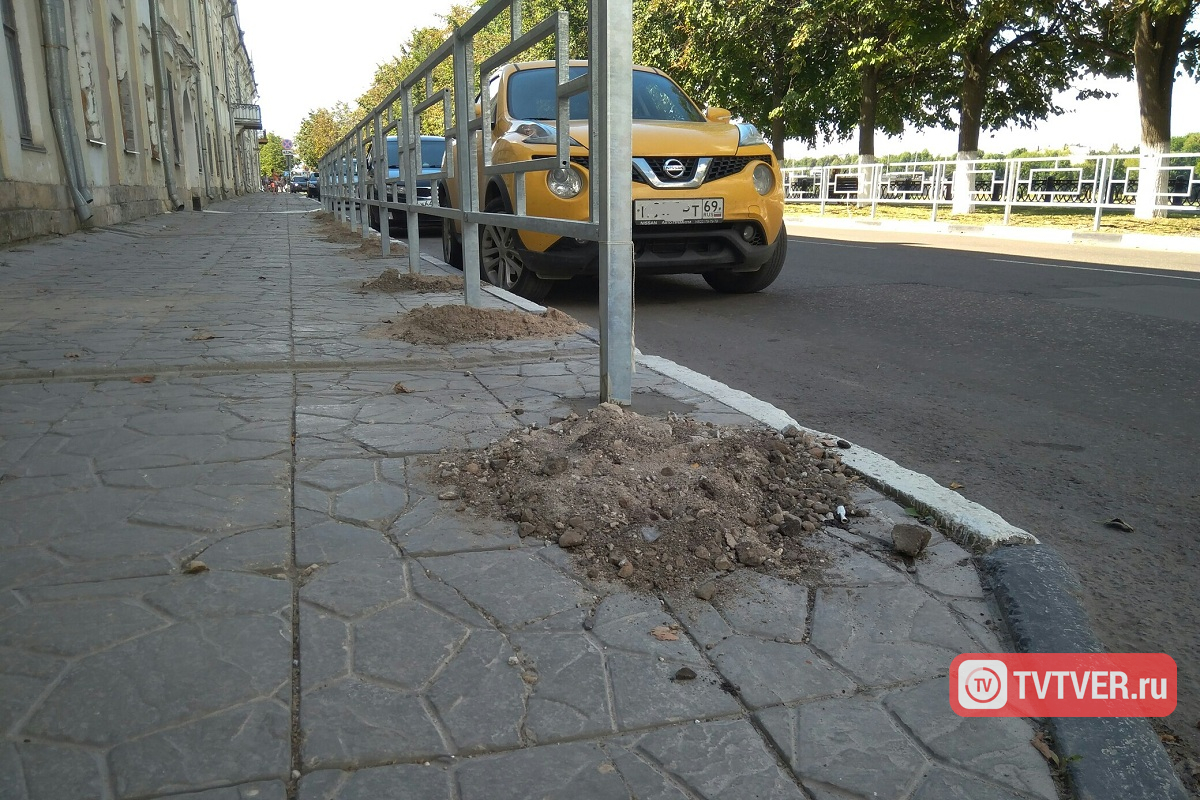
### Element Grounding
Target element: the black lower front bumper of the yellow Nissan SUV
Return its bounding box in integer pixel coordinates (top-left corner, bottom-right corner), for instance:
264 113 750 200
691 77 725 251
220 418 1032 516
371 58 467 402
521 223 775 279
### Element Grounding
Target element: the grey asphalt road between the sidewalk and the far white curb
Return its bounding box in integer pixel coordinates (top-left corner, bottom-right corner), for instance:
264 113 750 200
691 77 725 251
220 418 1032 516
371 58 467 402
504 229 1200 757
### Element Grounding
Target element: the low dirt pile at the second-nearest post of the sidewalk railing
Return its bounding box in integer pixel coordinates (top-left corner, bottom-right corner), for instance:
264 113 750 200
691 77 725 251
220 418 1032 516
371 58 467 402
373 303 583 344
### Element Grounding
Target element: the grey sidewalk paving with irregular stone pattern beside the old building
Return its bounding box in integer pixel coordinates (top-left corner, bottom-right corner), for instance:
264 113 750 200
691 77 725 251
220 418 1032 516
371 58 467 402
0 194 1057 800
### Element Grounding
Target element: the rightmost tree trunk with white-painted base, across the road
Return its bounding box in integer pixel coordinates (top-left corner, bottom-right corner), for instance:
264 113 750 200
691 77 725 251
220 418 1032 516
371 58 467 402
1133 11 1188 219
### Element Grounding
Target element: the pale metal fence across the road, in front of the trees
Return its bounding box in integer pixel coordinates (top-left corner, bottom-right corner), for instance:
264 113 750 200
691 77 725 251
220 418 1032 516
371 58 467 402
784 152 1200 229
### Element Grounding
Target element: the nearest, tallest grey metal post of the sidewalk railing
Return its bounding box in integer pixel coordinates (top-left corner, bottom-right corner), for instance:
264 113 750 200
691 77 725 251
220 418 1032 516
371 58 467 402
588 0 634 405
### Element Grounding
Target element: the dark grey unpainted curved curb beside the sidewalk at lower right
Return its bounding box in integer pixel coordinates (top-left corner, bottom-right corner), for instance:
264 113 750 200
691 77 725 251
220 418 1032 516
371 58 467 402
980 546 1188 800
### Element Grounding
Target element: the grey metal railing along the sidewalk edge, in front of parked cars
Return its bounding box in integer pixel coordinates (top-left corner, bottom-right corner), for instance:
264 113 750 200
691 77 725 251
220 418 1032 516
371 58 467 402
320 0 634 404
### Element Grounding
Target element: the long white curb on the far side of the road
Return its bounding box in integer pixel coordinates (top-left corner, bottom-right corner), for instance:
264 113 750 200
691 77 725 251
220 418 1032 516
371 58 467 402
784 215 1200 253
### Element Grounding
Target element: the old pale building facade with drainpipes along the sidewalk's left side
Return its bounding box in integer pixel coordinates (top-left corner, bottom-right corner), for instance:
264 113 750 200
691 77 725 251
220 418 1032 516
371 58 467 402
0 0 262 243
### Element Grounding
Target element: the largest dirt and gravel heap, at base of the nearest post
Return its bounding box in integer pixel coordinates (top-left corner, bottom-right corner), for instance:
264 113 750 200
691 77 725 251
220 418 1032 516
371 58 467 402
436 403 866 596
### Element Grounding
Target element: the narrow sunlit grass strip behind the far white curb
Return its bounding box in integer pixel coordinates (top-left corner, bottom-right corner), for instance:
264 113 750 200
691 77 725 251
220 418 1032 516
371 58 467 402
785 203 1200 236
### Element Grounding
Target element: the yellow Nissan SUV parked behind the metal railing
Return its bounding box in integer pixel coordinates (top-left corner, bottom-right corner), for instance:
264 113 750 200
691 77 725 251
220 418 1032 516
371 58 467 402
438 61 787 301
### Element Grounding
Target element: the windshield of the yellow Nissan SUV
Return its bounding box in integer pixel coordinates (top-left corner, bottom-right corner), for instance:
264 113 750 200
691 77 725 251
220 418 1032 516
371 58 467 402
509 66 704 122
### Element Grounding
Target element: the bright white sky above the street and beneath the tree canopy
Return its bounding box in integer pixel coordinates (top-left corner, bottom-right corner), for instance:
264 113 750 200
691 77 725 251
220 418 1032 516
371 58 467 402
238 0 1200 158
